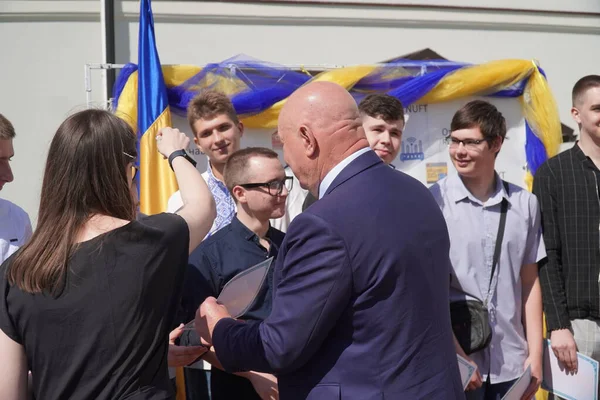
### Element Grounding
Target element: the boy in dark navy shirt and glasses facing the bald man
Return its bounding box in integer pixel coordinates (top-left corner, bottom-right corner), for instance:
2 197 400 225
181 148 292 400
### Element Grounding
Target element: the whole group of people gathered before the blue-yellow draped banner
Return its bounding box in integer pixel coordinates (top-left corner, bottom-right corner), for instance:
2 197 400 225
0 75 600 400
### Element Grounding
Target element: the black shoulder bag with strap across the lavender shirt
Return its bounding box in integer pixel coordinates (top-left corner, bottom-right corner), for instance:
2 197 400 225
450 181 508 354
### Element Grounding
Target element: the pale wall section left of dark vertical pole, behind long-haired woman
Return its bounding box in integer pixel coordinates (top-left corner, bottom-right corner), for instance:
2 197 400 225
0 2 102 223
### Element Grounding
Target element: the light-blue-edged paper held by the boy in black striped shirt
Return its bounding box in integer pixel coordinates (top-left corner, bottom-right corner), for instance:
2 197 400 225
542 340 598 400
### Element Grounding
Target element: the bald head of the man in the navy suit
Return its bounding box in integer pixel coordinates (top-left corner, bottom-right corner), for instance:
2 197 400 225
278 82 369 196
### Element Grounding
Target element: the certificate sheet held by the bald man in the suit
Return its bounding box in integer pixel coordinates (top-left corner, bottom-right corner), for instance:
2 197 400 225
184 257 273 330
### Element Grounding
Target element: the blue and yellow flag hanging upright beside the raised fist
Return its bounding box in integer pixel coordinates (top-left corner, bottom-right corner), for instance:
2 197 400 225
137 0 177 215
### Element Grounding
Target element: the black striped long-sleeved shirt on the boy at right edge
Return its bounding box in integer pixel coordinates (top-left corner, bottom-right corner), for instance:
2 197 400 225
533 144 600 331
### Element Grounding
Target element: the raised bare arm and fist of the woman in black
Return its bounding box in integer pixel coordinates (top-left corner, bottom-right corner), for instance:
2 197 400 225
156 128 217 253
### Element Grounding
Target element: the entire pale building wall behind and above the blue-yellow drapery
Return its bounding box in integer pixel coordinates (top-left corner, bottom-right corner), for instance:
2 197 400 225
0 0 600 220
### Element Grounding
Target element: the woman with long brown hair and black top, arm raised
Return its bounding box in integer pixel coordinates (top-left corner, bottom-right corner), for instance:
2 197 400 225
0 110 215 400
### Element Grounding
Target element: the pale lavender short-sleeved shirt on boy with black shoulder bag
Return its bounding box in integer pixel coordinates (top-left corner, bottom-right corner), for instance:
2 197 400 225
430 174 546 383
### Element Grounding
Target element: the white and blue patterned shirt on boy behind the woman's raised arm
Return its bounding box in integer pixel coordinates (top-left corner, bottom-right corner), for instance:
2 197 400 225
167 163 237 239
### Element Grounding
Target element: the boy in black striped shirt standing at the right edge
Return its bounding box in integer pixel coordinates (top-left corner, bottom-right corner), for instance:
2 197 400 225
533 75 600 388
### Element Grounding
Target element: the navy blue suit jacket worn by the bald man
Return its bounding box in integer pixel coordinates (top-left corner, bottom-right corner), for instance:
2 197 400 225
213 151 464 400
